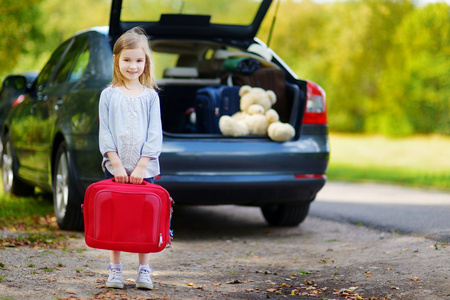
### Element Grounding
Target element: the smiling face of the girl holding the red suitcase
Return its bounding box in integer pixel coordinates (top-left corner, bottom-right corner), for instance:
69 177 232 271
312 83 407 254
114 48 145 83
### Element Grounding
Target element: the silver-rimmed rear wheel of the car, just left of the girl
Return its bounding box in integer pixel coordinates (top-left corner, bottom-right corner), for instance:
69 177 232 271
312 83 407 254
53 142 83 230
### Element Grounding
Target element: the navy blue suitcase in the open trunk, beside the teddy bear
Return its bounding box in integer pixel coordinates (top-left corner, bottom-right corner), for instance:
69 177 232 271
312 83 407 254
194 85 240 134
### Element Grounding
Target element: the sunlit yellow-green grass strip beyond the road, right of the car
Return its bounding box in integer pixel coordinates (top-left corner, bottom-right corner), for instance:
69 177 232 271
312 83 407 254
327 133 450 191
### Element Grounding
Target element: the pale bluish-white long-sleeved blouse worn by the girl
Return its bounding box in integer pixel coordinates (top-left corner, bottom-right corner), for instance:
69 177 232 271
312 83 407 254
99 87 163 178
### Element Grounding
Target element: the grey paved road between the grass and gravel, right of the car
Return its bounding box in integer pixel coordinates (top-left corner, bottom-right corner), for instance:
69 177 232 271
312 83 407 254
309 182 450 242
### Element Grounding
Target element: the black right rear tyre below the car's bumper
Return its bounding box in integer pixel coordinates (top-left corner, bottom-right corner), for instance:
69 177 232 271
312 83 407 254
261 202 310 227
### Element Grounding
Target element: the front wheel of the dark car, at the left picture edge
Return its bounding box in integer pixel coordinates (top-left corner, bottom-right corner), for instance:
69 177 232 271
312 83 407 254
1 134 34 196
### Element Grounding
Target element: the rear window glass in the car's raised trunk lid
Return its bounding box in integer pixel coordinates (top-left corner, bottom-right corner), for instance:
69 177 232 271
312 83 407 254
120 0 262 25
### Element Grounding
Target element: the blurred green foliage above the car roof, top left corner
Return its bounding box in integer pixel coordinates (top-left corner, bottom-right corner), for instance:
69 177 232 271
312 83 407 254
0 0 111 79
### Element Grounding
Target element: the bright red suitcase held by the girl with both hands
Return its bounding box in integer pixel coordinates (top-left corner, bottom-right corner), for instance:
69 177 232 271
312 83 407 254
83 179 173 253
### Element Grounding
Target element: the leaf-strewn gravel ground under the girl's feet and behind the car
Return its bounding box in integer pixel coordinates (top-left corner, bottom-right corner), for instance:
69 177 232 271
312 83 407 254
0 206 450 300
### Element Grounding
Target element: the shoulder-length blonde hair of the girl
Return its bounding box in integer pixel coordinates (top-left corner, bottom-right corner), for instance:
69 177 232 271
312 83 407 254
111 27 158 89
